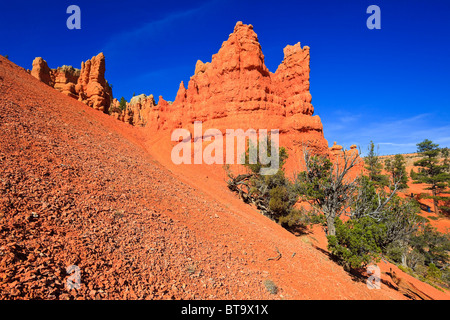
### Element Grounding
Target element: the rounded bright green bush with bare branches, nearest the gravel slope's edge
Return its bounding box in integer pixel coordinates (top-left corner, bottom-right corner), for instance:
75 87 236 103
327 176 423 269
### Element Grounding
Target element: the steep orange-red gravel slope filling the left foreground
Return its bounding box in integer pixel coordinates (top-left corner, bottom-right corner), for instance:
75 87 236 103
0 57 449 299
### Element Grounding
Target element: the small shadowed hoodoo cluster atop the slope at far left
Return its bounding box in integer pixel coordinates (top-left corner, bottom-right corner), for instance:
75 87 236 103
31 53 112 113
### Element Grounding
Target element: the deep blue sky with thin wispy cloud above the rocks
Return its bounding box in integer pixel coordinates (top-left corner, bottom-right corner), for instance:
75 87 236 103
0 0 450 154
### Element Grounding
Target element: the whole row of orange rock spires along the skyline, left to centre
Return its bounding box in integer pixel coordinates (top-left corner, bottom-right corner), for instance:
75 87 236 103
32 22 353 174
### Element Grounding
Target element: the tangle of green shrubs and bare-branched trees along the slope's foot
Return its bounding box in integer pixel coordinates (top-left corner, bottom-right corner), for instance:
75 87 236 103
228 138 450 286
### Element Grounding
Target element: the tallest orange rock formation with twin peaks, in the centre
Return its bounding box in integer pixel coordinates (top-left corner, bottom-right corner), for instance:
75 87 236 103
141 22 328 171
